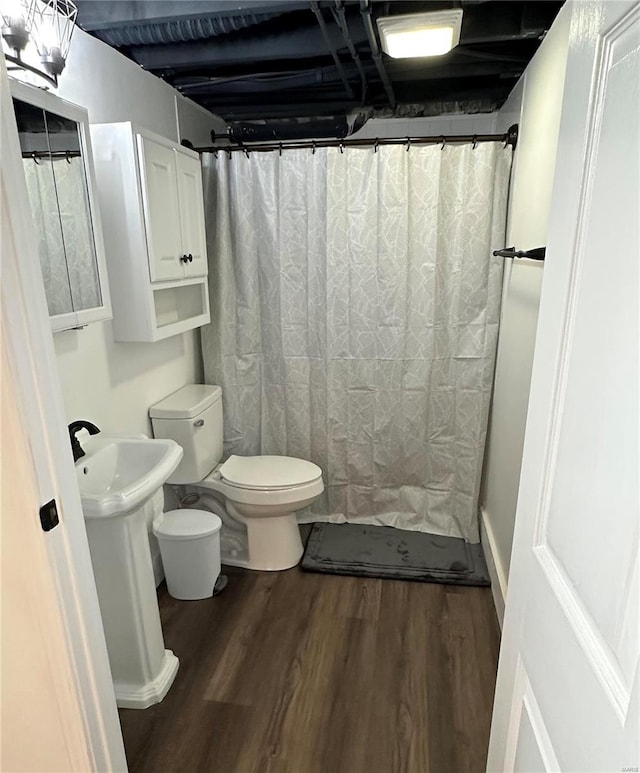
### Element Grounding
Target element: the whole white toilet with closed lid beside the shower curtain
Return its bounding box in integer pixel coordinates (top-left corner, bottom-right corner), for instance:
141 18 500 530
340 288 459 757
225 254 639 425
149 384 324 571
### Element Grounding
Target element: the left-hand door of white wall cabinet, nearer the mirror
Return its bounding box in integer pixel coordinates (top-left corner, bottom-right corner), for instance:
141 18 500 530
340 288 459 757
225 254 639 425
137 135 184 282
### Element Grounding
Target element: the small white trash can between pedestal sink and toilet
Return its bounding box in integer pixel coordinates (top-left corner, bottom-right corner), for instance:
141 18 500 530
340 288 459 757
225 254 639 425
153 508 222 600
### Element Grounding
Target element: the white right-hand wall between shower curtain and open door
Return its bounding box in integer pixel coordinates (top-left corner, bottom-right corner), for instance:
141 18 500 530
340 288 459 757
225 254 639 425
481 6 570 619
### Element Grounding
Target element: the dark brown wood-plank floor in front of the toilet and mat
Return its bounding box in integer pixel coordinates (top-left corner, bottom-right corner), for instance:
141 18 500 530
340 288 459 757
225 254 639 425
120 568 499 773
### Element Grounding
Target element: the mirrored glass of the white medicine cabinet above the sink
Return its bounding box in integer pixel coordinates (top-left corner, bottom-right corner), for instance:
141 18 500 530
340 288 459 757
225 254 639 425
13 89 110 329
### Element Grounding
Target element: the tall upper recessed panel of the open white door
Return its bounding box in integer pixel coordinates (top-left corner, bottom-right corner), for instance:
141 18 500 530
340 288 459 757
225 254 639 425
541 10 640 646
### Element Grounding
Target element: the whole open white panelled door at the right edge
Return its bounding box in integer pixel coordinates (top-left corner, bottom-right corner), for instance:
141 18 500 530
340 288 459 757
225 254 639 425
488 0 640 771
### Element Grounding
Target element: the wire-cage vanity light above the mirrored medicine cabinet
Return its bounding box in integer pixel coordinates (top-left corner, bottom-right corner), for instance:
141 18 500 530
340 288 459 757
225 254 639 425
0 0 78 86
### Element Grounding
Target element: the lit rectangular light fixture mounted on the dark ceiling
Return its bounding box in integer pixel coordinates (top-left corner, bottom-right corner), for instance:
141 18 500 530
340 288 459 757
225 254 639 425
377 8 462 59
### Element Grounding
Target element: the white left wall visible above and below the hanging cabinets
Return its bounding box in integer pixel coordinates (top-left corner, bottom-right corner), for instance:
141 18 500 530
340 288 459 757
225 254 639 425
26 29 224 433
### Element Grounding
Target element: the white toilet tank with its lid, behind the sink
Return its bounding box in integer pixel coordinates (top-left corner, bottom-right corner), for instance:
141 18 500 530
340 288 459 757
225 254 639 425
149 384 222 483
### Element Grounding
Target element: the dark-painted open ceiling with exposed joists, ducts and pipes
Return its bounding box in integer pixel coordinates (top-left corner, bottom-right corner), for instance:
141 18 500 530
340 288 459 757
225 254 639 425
76 0 562 140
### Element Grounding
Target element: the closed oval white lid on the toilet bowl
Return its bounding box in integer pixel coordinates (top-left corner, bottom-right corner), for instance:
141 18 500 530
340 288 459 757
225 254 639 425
220 456 322 489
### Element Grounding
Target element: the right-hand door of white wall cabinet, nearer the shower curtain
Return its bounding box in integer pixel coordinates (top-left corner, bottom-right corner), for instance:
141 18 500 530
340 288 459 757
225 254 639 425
175 150 207 276
